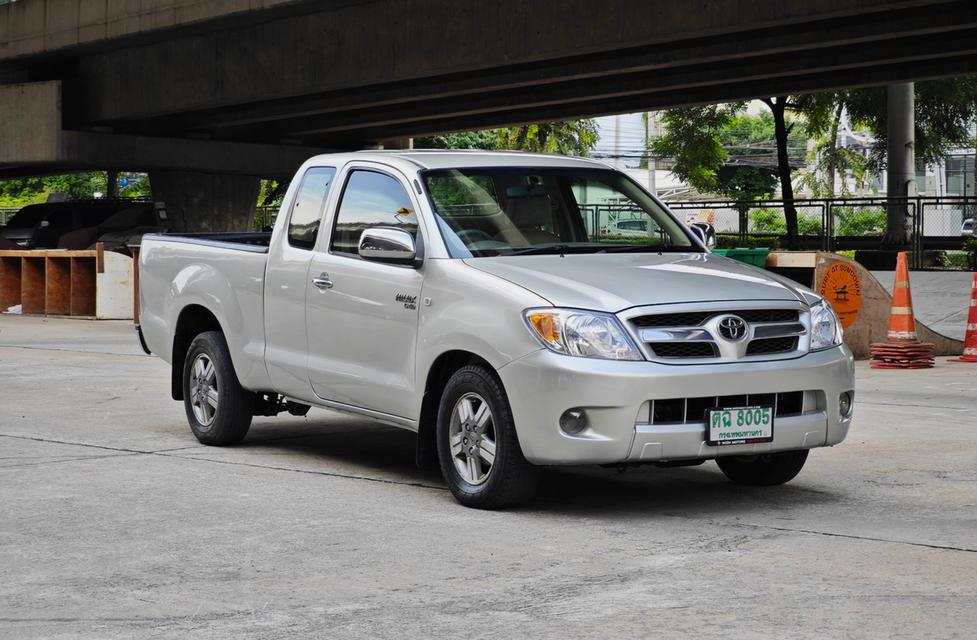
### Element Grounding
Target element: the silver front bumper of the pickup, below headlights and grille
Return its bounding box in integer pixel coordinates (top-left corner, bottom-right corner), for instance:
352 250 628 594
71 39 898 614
499 345 855 465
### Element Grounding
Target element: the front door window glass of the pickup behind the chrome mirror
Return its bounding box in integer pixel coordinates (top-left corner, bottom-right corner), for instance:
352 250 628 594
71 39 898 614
330 169 417 254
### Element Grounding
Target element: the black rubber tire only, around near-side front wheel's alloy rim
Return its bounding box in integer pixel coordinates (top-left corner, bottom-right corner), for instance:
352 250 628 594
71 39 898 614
437 365 539 509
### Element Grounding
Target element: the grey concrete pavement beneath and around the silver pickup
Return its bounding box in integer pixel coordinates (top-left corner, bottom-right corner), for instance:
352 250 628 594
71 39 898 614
0 316 977 639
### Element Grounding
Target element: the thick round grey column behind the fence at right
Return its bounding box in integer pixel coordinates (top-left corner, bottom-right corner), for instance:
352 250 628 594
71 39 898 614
882 82 916 247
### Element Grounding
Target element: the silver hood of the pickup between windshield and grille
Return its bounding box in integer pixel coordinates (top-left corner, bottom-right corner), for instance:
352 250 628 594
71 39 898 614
465 253 809 313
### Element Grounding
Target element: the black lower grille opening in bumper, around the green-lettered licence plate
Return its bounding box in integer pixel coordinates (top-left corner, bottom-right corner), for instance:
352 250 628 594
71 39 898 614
648 391 812 425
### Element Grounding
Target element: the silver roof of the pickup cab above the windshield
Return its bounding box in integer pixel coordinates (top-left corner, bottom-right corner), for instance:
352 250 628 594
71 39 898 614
310 149 609 169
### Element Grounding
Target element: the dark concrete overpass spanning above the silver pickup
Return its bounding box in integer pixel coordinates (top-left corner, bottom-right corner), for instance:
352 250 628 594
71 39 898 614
0 0 977 229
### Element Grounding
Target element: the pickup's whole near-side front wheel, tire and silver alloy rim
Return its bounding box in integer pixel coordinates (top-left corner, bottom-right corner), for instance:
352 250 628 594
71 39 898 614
437 365 539 509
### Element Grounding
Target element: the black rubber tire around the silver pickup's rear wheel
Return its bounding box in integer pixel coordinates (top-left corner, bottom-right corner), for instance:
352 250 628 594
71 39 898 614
183 331 255 447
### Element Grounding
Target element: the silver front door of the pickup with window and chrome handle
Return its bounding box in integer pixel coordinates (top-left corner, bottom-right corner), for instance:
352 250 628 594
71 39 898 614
306 166 423 419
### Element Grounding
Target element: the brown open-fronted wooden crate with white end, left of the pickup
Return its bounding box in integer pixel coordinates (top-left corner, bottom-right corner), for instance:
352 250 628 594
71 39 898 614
0 245 134 319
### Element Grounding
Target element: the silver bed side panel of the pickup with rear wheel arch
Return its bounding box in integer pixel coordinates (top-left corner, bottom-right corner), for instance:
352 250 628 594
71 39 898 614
139 237 270 390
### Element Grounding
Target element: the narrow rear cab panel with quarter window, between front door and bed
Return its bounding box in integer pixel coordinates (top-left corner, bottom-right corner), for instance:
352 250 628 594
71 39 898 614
265 167 336 401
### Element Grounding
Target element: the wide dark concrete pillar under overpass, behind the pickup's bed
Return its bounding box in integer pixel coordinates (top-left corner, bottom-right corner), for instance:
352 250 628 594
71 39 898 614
149 171 260 232
